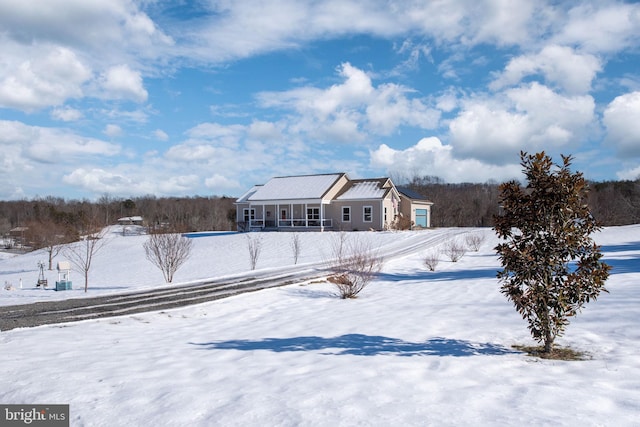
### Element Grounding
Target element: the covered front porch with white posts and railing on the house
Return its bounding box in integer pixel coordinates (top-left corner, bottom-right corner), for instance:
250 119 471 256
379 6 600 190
243 201 333 231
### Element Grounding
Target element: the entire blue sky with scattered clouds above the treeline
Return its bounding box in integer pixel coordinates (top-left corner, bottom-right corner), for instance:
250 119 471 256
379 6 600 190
0 0 640 200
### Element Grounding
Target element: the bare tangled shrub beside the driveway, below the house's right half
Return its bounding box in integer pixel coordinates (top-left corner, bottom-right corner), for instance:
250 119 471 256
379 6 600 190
327 234 382 299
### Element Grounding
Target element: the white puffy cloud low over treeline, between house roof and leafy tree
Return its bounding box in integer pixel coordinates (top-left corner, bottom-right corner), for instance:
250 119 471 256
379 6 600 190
370 137 521 182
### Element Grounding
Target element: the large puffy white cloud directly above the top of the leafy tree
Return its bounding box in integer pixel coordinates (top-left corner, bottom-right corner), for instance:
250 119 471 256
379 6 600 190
449 83 595 164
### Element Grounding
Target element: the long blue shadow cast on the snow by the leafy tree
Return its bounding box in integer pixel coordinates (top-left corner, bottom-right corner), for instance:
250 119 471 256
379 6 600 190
190 334 519 357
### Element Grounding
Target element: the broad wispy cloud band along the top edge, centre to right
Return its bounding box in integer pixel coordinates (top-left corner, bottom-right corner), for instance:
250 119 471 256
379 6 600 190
182 0 547 68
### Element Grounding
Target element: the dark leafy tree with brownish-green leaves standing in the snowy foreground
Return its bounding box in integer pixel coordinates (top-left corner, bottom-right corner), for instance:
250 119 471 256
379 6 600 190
494 152 611 353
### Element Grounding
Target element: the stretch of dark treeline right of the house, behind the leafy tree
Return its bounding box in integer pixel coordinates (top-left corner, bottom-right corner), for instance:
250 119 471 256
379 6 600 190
404 176 640 227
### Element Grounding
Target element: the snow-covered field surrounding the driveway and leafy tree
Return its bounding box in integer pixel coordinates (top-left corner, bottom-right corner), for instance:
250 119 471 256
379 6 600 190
0 226 640 426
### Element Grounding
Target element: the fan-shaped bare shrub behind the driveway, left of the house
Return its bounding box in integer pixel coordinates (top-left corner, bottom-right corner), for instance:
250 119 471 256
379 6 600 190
143 233 193 283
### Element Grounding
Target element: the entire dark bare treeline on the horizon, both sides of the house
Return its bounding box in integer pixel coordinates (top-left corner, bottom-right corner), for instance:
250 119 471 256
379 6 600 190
0 176 640 241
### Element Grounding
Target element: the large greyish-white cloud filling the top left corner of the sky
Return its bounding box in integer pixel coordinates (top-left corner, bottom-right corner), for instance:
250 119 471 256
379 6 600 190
0 0 174 112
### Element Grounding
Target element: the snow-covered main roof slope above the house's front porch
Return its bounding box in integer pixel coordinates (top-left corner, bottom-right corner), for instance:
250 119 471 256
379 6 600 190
246 174 343 201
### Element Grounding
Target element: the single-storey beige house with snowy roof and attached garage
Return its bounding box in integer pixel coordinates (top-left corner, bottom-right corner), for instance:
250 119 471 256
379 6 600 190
235 173 432 231
